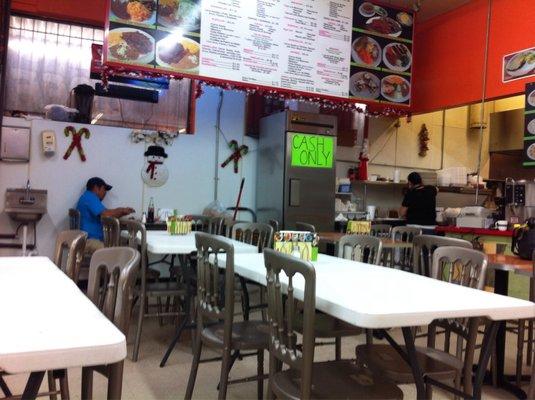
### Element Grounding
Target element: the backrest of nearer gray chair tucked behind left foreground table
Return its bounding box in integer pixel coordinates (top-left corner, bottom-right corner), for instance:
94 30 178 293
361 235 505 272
87 247 140 336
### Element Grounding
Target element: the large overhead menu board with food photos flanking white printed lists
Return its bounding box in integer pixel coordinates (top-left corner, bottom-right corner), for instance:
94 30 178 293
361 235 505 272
105 0 412 105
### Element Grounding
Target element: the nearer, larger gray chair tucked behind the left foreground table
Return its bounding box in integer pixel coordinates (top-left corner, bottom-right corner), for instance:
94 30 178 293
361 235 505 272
81 247 141 399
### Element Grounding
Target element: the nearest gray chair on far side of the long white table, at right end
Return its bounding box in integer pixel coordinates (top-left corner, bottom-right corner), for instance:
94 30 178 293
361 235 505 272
356 246 487 398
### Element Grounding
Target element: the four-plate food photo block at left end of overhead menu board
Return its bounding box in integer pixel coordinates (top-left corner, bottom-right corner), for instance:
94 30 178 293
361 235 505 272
105 0 200 75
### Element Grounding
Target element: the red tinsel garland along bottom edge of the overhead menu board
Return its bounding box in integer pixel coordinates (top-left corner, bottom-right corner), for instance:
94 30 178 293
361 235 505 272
102 65 411 118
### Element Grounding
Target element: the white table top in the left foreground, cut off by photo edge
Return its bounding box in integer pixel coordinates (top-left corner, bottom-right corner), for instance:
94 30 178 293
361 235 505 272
0 257 126 374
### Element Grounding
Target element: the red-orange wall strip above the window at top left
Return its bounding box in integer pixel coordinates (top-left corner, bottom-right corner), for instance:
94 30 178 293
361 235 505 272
11 0 106 27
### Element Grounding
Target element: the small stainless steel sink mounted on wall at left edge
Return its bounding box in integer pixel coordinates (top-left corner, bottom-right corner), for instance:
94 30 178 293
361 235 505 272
4 187 48 223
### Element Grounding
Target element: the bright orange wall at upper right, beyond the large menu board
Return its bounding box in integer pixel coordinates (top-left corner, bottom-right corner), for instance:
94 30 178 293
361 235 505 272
413 0 535 112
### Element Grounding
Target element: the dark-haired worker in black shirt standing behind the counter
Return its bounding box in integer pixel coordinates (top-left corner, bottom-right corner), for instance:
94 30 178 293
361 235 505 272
399 172 437 225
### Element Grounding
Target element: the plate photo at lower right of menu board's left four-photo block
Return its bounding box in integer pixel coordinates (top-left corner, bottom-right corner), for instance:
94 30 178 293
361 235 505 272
156 35 201 74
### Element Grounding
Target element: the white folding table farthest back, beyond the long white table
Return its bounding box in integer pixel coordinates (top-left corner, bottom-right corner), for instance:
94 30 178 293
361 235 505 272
147 231 258 367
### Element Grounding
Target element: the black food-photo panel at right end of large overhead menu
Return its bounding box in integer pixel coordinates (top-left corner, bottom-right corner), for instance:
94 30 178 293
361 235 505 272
349 0 414 105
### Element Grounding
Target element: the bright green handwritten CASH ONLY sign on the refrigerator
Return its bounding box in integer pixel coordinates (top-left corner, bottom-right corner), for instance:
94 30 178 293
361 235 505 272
290 133 334 168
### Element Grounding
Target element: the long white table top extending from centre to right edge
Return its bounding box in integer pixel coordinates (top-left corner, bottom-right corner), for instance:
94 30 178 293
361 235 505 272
219 254 535 329
